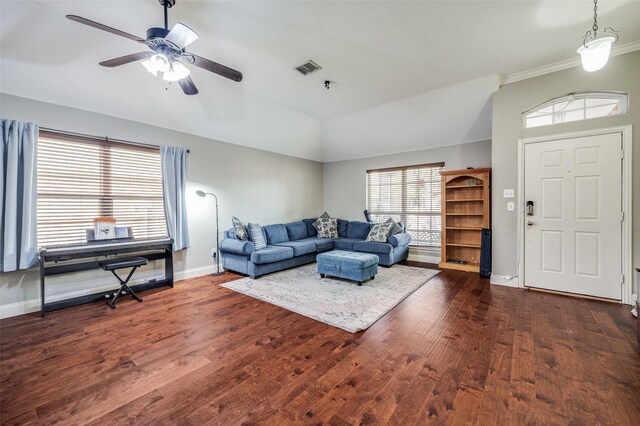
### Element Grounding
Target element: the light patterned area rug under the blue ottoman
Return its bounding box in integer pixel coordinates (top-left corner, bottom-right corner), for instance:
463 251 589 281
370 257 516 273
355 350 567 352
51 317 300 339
221 263 439 333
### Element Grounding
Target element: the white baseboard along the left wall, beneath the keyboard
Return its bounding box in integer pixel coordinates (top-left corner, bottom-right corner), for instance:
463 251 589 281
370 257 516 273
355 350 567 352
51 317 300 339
0 265 215 319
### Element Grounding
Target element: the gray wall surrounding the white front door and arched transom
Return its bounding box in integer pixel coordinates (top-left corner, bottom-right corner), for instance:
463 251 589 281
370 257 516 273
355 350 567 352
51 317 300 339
491 51 640 294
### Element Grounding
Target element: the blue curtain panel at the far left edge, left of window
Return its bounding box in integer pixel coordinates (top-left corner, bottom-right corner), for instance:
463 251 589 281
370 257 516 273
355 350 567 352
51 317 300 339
0 119 38 272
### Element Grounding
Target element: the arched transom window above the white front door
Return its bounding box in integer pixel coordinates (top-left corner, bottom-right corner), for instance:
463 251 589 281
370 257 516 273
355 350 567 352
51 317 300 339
522 92 628 129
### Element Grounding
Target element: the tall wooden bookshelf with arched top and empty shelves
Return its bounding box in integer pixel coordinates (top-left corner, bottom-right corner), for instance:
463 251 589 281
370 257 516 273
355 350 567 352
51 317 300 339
439 168 491 272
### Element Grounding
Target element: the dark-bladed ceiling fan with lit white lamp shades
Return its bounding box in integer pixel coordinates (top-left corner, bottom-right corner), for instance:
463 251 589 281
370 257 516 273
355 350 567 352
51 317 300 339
67 0 242 95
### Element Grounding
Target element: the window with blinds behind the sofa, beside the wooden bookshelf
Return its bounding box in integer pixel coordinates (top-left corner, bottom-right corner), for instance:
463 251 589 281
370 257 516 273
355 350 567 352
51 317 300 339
367 163 444 247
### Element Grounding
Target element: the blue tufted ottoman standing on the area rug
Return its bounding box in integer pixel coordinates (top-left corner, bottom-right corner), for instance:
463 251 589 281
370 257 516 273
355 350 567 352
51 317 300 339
316 250 379 285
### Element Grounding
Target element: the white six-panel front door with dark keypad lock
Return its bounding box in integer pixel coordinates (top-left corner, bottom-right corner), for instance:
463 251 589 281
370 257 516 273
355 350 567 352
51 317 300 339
524 133 622 300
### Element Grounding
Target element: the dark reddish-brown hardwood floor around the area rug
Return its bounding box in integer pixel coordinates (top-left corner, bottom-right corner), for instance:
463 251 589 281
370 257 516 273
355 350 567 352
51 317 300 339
0 271 640 425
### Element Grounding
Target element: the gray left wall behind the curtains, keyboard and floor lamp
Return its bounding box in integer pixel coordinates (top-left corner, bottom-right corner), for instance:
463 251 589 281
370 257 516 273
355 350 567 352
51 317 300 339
0 94 323 312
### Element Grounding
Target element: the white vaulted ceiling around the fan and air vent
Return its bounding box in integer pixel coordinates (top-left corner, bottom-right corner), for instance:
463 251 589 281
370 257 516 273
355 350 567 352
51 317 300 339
0 0 640 160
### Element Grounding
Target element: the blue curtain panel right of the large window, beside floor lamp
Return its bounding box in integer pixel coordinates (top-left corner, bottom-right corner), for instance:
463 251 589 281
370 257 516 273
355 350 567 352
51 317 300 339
160 146 189 251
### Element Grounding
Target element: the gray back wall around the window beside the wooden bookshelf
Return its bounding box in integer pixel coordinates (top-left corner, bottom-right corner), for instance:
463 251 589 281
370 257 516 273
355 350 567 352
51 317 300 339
324 141 491 262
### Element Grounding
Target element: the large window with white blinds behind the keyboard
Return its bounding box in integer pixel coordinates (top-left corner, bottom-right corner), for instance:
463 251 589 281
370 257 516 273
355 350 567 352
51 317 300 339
38 131 167 247
